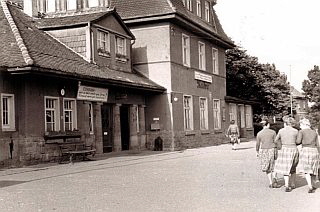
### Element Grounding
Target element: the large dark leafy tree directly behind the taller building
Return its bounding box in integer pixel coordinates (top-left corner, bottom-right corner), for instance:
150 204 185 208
226 47 290 115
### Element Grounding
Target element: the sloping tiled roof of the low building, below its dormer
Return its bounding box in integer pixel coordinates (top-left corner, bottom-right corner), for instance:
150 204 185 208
0 0 165 91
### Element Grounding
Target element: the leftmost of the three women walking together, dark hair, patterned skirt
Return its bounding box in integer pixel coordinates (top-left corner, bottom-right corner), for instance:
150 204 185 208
256 120 278 188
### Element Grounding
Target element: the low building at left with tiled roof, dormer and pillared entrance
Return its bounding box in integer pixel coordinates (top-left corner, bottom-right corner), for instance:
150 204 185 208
0 0 165 166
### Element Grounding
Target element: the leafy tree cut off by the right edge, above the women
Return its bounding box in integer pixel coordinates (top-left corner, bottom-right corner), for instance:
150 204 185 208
302 65 320 126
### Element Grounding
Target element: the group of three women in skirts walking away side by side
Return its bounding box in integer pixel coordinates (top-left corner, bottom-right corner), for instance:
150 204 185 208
256 116 320 193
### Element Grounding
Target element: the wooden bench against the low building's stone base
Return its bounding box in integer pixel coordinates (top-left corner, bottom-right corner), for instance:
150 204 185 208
59 142 96 163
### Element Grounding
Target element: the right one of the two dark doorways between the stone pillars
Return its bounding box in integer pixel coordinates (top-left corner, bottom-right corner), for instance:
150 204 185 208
120 105 130 150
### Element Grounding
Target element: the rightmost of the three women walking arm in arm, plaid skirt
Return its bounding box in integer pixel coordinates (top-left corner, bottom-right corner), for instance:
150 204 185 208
297 118 319 193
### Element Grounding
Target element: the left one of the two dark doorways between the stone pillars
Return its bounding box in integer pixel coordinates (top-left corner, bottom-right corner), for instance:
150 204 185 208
101 104 113 153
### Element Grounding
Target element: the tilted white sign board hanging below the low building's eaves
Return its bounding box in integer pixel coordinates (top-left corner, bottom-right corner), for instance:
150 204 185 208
77 85 108 102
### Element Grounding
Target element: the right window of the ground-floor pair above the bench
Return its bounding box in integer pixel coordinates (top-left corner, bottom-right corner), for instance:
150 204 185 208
63 99 77 131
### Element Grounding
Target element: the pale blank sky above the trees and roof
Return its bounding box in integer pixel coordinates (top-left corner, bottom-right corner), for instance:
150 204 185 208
214 0 320 91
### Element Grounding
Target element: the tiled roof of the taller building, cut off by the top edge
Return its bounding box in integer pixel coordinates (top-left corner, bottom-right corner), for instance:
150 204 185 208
111 0 234 46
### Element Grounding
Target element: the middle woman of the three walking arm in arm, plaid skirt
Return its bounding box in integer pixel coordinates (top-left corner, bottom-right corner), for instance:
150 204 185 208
274 116 299 192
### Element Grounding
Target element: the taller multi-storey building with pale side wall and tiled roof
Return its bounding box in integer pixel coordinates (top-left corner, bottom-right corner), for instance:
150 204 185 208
111 0 242 150
